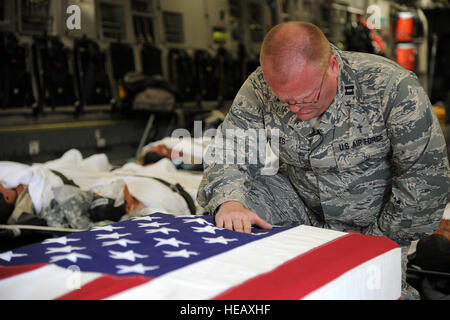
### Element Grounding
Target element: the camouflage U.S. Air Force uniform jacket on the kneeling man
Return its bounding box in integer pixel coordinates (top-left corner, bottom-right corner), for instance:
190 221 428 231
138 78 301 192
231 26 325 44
198 46 449 242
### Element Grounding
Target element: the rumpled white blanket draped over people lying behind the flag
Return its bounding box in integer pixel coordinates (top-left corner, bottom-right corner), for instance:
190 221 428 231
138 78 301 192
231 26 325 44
0 149 202 215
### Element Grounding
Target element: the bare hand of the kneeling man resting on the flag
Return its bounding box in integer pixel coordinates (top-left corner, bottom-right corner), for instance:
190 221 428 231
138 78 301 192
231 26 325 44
216 201 272 233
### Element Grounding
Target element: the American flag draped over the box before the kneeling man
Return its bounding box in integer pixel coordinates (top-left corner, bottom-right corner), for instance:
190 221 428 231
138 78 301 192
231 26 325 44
0 213 401 300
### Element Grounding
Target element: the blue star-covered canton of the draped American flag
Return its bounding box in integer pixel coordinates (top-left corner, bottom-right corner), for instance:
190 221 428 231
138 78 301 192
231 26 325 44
0 213 287 277
